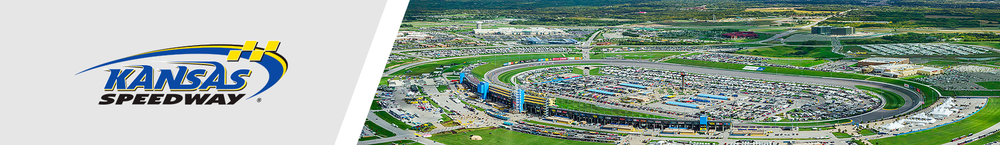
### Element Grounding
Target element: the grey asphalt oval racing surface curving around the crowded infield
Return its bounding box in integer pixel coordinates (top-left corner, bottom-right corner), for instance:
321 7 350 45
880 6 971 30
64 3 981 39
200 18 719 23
485 60 923 123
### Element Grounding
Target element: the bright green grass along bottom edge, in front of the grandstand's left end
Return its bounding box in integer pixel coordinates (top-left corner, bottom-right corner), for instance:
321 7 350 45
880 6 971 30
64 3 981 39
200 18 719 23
427 129 605 145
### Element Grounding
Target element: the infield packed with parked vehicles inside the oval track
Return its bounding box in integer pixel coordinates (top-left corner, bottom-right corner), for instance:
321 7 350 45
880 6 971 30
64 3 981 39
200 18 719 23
515 66 881 121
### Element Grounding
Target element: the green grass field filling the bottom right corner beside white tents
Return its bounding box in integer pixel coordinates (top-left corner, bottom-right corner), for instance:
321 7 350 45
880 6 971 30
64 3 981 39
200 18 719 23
870 98 1000 145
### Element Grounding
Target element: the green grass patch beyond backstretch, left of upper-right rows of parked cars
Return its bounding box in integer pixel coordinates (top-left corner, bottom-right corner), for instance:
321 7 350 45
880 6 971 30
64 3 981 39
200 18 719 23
736 46 844 58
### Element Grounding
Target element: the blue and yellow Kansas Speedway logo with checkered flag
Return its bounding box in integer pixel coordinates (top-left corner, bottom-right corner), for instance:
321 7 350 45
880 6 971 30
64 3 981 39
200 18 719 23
76 41 288 105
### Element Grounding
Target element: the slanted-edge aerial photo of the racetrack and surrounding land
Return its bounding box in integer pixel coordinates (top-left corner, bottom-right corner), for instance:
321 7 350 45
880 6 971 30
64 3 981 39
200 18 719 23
358 0 1000 145
